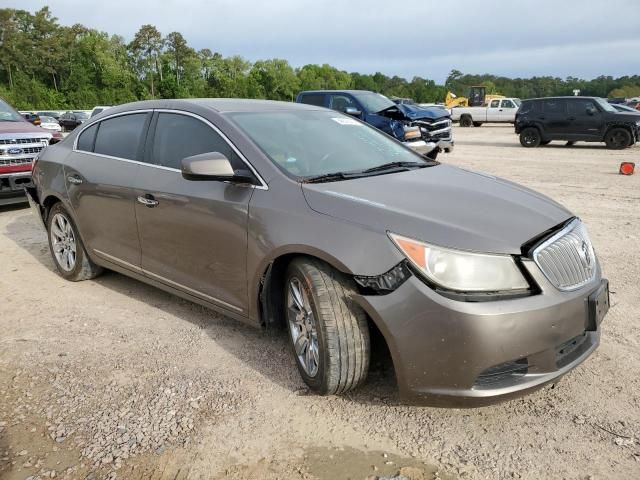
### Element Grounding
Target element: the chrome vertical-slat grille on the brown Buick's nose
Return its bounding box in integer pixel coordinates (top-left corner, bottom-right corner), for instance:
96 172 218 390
533 219 597 290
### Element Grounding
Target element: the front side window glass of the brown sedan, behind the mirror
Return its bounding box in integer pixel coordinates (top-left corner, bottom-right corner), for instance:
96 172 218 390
153 113 242 170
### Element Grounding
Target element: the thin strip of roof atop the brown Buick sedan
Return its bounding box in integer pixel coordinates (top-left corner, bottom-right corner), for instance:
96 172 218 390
96 98 324 115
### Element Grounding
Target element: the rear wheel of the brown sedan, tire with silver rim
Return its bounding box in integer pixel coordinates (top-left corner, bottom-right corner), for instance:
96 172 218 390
47 203 102 282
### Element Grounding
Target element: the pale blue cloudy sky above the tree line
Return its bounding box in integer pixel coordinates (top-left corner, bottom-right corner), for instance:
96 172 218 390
8 0 640 83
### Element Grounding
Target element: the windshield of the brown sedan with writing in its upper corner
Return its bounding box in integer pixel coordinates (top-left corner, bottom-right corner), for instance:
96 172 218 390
229 110 427 179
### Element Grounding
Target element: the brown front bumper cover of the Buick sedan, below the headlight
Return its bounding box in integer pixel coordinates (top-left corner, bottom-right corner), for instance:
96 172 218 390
356 261 606 407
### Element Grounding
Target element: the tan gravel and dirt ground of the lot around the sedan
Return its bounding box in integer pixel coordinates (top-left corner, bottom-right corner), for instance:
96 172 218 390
0 126 640 480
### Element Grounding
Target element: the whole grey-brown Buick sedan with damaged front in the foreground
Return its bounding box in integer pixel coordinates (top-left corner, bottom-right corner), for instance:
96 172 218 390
28 99 609 405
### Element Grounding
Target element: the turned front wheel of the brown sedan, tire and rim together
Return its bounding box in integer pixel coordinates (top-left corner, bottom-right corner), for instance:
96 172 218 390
283 257 370 395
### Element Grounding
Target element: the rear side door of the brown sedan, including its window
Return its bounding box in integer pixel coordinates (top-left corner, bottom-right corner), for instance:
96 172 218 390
64 112 151 271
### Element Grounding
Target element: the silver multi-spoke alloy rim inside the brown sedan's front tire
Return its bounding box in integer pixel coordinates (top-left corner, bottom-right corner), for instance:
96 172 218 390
287 277 320 377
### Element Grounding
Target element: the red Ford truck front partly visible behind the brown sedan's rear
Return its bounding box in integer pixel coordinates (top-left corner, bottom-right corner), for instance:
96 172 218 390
0 99 63 205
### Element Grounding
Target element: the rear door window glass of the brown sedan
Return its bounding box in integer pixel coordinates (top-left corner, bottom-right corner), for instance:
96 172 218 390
94 113 147 160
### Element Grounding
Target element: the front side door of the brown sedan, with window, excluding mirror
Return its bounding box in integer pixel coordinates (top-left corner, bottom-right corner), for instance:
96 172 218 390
135 111 254 316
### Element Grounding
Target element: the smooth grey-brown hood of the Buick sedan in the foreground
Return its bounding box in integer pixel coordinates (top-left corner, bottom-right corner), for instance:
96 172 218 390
302 165 572 254
